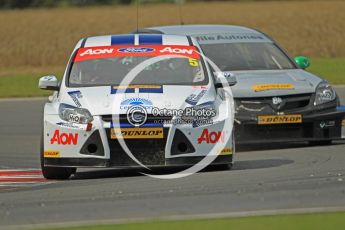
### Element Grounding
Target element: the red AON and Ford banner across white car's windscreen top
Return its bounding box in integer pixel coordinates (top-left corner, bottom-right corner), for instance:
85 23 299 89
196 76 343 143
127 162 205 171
74 45 200 62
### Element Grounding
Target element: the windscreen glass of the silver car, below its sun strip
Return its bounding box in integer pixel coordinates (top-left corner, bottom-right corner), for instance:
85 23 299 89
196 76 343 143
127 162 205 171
201 42 296 71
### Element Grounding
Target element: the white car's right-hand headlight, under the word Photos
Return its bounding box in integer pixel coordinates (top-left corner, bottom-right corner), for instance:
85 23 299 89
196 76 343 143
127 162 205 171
182 102 217 121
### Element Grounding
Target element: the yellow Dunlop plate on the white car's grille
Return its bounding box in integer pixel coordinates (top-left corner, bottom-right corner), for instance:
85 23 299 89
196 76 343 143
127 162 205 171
110 128 163 139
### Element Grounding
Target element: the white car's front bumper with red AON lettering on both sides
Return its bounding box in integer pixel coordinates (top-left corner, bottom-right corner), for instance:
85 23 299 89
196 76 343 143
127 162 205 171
43 115 233 168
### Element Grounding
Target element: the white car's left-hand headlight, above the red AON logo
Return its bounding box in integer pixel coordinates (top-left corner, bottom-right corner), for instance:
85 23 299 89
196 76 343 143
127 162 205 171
59 104 93 124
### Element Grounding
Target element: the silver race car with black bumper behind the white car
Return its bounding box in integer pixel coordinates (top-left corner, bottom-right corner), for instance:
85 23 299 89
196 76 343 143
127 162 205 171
140 25 345 144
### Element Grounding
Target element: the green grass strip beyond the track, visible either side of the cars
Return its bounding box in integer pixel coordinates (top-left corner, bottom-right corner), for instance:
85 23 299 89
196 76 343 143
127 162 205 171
0 58 345 98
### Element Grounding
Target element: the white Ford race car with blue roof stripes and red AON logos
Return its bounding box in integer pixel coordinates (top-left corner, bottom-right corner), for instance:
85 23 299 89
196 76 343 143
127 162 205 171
39 34 234 179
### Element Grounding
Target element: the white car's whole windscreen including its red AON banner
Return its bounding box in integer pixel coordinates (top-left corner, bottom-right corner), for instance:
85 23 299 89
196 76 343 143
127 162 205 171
69 46 208 87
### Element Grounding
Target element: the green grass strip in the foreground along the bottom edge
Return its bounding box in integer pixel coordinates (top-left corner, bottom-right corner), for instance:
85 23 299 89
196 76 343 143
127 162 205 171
40 213 345 230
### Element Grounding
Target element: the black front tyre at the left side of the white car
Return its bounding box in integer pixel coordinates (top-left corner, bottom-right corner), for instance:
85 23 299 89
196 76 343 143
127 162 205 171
40 135 77 180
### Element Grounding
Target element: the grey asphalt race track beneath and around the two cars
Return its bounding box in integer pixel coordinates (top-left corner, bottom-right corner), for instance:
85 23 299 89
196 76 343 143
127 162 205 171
0 88 345 228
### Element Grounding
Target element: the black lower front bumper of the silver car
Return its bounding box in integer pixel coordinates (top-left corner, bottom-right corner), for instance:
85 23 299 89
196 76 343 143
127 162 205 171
235 109 345 144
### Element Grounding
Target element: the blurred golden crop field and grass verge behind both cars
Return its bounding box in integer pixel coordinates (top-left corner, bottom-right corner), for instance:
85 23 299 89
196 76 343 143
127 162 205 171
0 0 345 97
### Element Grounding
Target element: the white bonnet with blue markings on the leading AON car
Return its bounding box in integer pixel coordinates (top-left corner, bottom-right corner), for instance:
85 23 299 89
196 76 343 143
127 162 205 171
60 85 215 115
